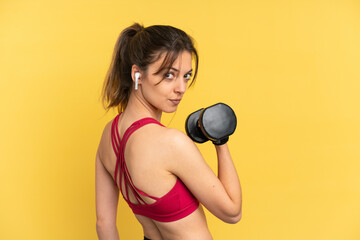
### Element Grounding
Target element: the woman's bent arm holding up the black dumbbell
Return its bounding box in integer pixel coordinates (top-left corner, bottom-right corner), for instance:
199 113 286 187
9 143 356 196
166 129 242 223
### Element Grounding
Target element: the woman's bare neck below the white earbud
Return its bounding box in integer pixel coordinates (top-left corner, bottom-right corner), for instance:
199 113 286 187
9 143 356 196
123 89 162 122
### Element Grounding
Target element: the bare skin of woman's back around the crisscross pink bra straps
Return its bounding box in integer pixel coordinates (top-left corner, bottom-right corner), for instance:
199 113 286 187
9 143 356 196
99 113 212 239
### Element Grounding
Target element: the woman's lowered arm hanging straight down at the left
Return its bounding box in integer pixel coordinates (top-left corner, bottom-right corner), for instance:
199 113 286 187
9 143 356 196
95 150 119 240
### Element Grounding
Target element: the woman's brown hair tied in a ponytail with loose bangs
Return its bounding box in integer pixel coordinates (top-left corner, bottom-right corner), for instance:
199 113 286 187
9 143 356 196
102 23 199 112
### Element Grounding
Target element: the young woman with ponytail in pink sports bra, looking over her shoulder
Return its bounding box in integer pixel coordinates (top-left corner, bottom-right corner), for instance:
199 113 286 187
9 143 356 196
96 24 242 240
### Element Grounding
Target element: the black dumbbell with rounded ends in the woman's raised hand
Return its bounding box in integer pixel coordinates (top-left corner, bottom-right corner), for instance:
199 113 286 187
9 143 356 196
185 103 237 145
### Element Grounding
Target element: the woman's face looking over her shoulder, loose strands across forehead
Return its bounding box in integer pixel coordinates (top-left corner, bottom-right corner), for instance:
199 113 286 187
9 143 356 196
140 51 192 113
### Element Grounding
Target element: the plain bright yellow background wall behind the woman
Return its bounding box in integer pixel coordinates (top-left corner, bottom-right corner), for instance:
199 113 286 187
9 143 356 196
0 0 360 240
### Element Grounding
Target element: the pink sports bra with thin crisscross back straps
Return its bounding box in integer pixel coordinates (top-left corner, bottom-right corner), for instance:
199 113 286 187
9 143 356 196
111 113 199 222
